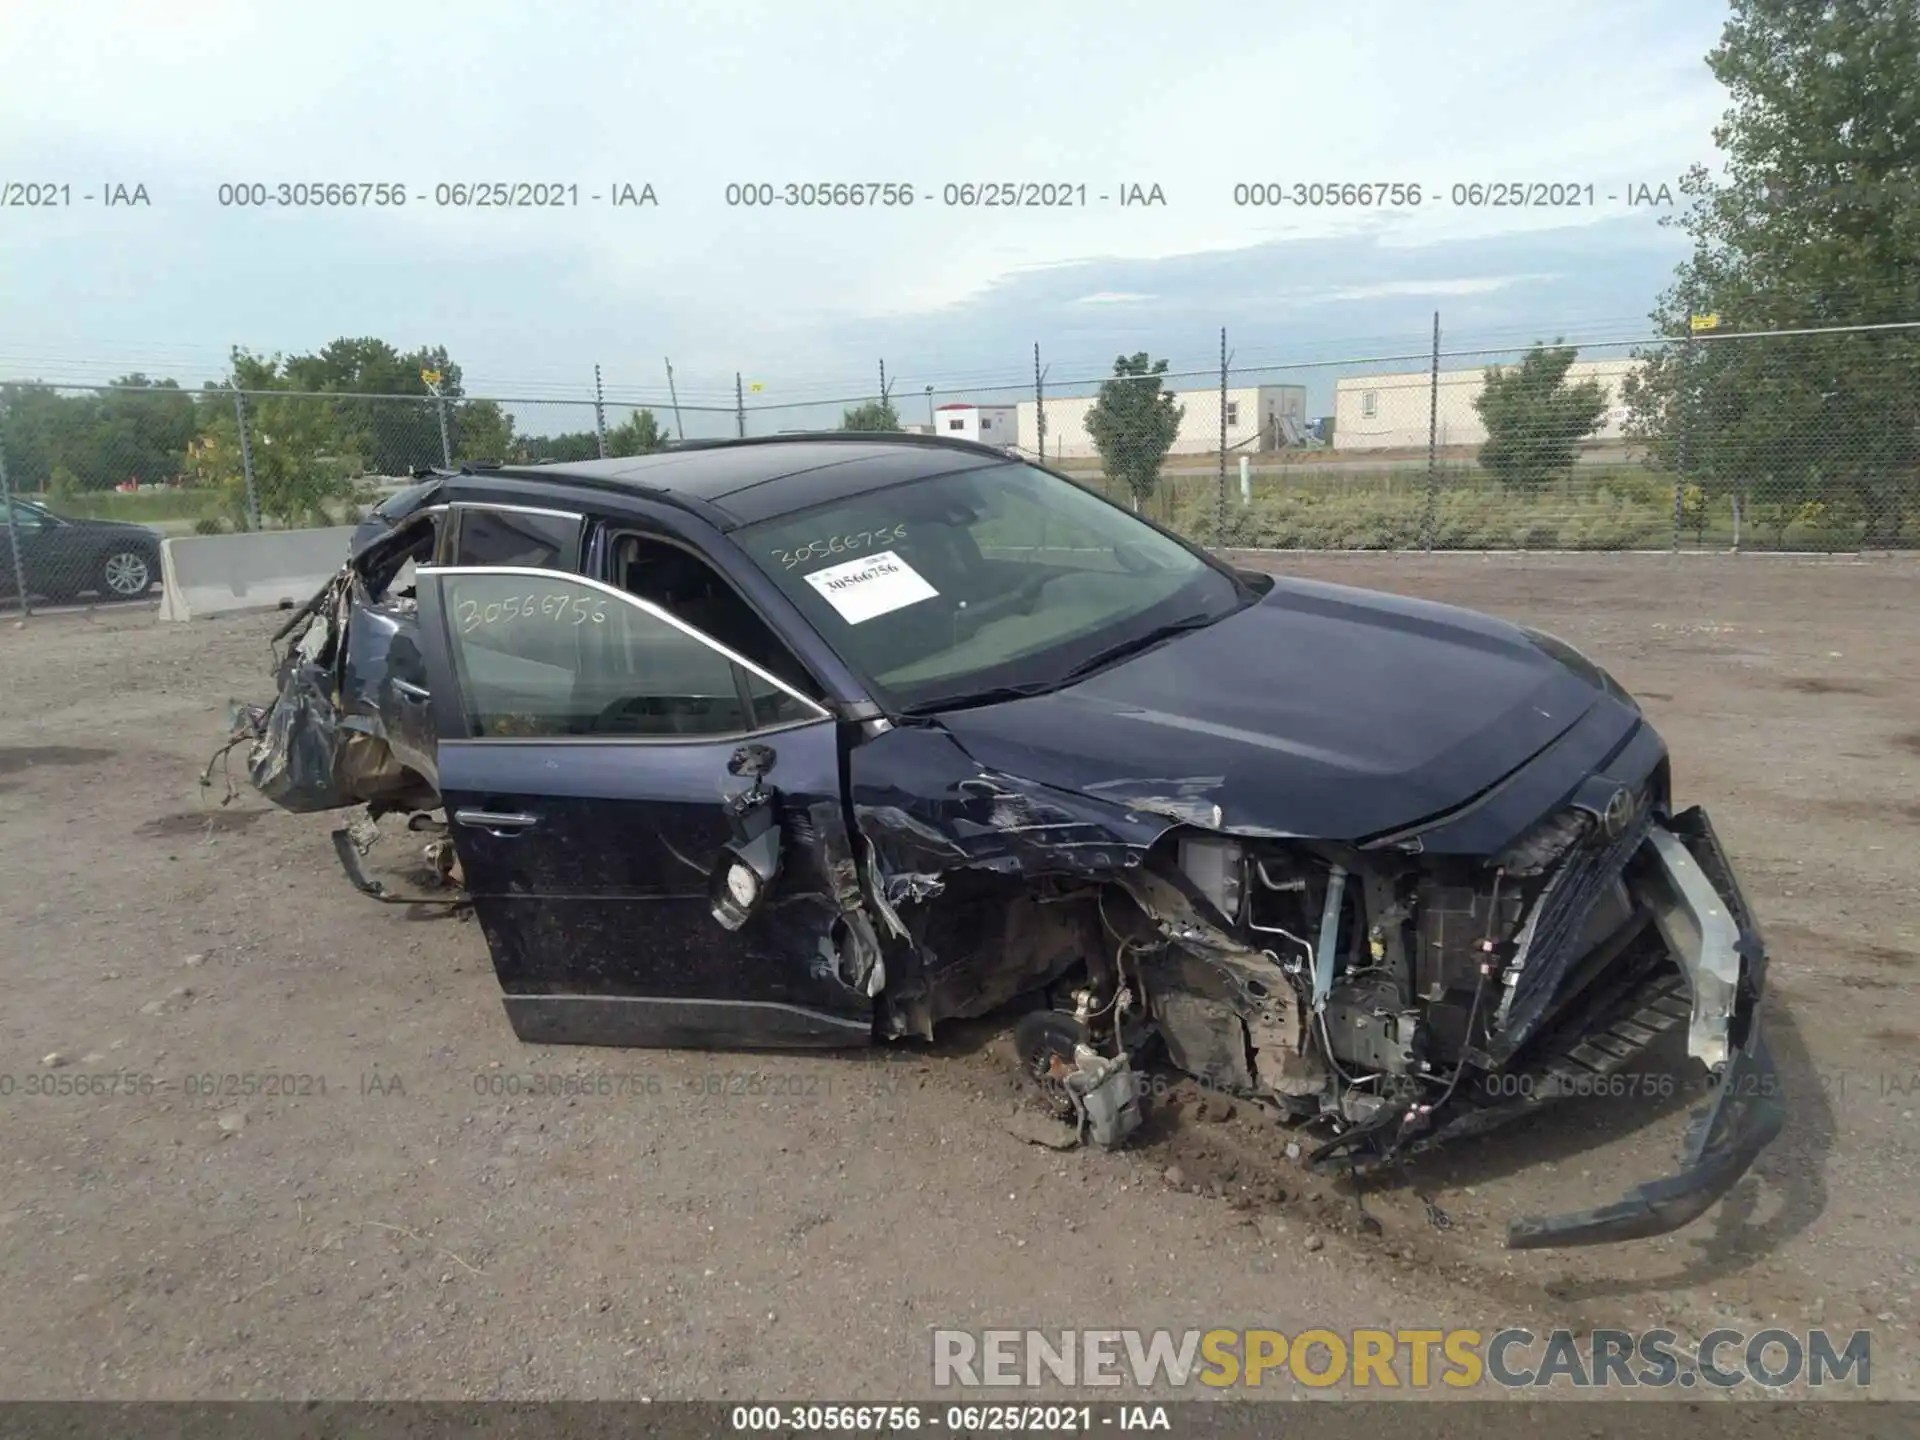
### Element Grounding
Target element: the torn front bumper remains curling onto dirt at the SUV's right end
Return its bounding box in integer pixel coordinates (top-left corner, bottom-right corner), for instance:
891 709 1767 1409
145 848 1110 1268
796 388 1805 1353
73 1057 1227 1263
1507 806 1786 1250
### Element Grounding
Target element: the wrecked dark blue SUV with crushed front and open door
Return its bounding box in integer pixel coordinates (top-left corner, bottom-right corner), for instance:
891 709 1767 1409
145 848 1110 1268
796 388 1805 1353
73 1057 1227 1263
224 434 1784 1246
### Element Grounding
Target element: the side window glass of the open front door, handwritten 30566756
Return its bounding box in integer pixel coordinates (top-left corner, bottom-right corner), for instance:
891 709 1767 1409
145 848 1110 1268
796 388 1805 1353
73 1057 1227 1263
442 572 814 739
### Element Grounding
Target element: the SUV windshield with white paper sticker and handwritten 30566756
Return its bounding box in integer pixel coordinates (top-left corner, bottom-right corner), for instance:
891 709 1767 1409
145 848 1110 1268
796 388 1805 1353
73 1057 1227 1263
733 465 1248 708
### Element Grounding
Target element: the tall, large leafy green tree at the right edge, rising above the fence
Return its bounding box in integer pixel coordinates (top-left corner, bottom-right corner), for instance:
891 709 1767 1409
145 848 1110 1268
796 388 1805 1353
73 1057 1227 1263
1626 0 1920 547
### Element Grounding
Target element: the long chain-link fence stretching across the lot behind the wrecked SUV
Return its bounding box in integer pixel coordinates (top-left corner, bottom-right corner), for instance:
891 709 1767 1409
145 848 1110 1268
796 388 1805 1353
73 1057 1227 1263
0 317 1920 609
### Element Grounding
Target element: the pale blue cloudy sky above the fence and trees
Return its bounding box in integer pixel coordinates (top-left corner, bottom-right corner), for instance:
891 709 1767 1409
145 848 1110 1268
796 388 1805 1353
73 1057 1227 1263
0 0 1726 428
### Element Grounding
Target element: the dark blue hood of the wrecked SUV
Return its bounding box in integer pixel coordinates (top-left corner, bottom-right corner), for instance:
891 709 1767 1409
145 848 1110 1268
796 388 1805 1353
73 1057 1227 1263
939 578 1636 841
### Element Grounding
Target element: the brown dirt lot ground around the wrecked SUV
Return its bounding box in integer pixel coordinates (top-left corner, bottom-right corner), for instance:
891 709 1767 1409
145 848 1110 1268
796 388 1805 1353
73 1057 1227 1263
0 557 1920 1400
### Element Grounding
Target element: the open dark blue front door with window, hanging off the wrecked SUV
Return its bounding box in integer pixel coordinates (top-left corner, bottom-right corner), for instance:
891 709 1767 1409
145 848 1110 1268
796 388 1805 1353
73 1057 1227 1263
419 566 872 1048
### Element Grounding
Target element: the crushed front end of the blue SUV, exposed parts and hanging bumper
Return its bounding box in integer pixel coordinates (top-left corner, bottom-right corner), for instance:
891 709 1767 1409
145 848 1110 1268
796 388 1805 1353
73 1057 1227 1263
1133 779 1784 1248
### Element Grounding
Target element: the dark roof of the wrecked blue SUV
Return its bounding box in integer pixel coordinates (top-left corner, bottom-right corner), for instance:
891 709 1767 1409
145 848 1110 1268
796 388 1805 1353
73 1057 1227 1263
380 430 1020 530
